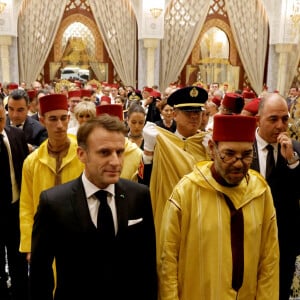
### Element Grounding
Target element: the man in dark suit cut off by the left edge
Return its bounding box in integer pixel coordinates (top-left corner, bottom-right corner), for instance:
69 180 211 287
0 102 28 300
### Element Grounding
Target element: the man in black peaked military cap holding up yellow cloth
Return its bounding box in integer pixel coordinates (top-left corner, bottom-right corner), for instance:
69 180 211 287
139 86 209 239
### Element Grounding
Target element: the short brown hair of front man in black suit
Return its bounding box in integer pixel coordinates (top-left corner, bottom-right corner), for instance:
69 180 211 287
77 114 126 149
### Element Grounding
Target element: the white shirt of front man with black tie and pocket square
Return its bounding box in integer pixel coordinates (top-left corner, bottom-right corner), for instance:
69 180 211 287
81 172 118 232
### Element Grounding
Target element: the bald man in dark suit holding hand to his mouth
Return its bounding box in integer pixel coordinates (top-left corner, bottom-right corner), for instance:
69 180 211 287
252 93 300 300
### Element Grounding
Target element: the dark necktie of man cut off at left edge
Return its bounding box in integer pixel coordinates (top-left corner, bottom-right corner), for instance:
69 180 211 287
0 134 12 204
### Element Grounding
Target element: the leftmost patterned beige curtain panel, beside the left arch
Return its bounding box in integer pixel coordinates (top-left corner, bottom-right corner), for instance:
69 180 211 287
18 0 67 83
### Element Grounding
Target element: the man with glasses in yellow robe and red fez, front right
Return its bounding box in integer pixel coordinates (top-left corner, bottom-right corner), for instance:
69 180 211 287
158 115 279 300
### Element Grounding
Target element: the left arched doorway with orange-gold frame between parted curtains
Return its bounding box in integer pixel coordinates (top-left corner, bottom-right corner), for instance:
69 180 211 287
44 1 114 82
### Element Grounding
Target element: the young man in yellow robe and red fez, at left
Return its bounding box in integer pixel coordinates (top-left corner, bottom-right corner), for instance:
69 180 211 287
20 94 84 261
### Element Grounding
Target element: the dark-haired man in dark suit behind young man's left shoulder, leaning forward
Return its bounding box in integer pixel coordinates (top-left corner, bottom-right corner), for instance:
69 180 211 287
6 89 48 152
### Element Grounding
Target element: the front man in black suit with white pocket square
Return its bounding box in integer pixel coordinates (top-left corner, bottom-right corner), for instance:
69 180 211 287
30 114 157 300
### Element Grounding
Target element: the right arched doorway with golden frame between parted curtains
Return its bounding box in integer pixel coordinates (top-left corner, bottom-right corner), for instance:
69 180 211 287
186 18 244 91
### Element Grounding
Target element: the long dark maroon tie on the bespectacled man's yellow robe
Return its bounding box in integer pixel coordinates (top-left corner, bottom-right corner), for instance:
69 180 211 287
223 194 244 291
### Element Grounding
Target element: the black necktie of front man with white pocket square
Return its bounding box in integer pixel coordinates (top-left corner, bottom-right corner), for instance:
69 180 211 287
95 190 115 241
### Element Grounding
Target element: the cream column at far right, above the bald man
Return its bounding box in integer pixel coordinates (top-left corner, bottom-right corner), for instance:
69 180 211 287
275 44 295 95
